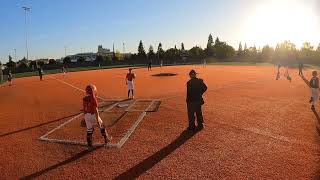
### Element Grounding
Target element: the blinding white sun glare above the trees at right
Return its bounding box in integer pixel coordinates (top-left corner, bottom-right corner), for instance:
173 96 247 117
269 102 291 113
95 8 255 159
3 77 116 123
244 0 319 47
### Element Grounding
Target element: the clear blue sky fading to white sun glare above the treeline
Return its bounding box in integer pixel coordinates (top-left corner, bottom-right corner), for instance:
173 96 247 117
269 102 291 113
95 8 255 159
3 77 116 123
0 0 320 62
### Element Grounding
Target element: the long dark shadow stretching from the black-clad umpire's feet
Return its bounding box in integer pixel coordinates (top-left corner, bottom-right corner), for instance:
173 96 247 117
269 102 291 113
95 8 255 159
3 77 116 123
114 130 199 180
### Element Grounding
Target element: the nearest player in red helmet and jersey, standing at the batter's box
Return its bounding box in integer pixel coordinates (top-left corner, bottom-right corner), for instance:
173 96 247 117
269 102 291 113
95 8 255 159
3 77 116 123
83 84 111 148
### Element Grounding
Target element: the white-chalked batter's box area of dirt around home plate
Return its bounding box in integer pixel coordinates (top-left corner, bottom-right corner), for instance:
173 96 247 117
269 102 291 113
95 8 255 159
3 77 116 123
39 99 161 148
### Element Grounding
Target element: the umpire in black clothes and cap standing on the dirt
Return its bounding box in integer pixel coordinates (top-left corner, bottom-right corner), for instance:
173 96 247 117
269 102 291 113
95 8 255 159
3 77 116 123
187 70 207 130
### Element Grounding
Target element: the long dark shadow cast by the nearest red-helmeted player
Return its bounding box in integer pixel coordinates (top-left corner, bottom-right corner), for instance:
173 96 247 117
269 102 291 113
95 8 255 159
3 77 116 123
20 146 103 179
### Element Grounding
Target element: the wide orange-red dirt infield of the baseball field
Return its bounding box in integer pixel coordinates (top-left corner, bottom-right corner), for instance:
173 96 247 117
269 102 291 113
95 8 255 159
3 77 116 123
0 65 320 179
